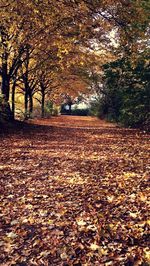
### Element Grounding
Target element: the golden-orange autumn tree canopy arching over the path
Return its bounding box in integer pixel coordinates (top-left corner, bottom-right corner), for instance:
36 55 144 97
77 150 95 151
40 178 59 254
0 0 149 125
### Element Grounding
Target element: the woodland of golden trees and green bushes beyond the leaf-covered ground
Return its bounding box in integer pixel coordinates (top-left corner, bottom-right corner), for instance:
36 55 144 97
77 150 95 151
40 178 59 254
0 0 150 128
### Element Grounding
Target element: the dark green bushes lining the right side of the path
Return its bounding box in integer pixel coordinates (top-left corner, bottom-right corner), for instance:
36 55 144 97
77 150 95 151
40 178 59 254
97 56 150 127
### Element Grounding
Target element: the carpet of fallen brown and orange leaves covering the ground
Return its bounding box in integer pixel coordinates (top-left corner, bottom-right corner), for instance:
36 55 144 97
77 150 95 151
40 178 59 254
0 116 150 266
